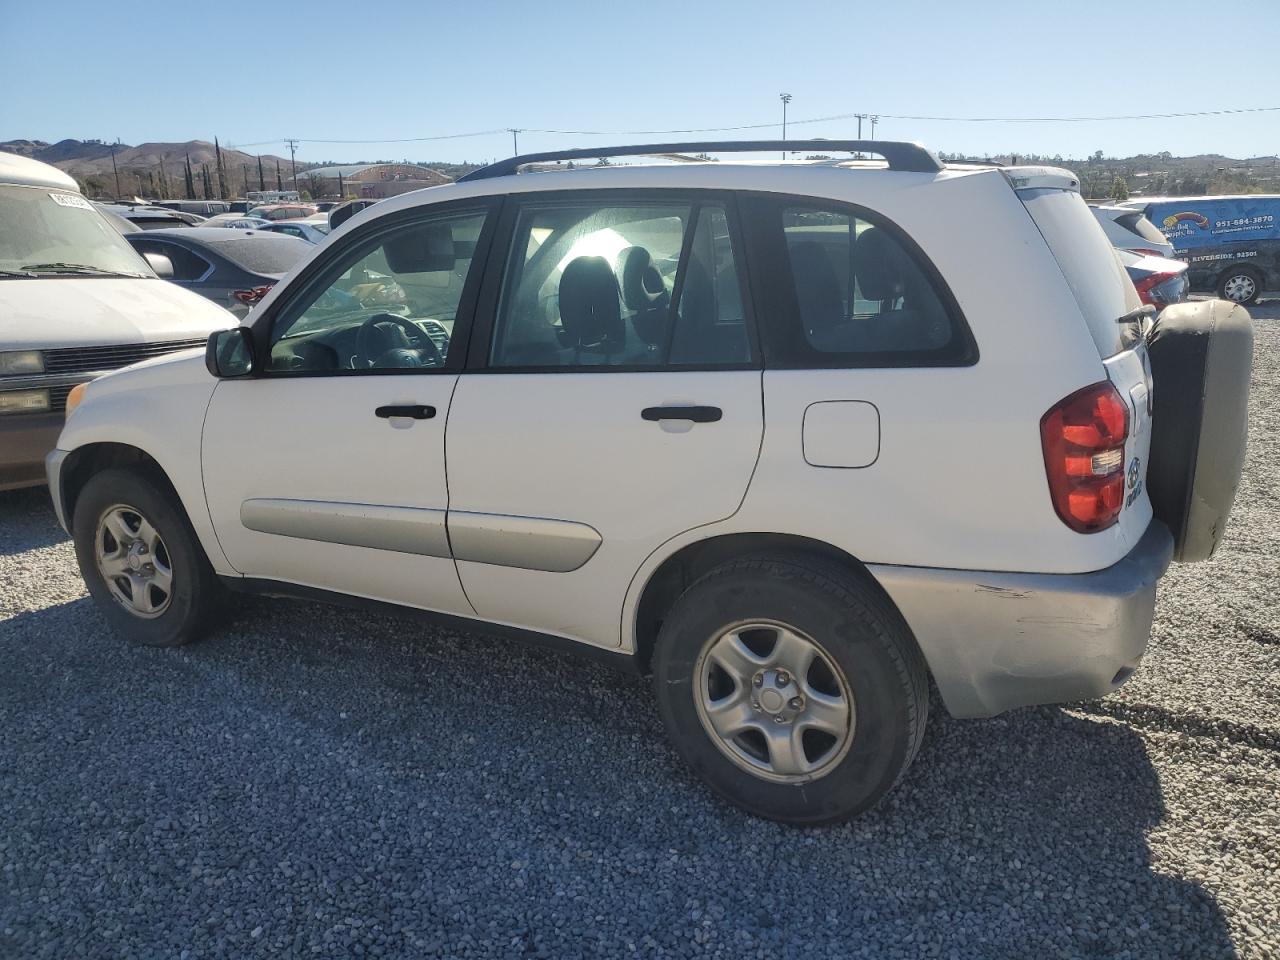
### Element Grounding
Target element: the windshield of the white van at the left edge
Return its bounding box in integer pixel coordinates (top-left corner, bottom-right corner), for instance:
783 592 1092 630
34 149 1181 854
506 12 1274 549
0 184 155 276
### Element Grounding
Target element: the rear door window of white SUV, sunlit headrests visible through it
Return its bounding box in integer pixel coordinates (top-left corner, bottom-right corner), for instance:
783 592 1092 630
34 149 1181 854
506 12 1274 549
490 201 751 369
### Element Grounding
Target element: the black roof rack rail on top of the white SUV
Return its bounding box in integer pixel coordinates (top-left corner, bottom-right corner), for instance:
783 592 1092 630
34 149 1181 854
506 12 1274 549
458 140 943 183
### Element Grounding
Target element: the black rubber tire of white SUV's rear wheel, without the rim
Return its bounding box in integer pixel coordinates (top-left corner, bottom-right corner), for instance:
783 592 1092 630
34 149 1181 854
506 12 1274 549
653 556 929 824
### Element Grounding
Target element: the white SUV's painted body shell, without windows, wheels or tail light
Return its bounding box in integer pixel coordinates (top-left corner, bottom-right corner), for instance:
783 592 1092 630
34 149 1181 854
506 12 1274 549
51 154 1172 716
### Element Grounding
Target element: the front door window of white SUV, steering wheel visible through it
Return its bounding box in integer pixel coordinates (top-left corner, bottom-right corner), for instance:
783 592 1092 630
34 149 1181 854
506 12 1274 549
269 211 485 374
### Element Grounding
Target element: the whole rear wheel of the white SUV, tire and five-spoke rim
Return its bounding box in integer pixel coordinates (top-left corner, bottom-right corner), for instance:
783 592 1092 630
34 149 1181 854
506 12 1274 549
653 557 928 824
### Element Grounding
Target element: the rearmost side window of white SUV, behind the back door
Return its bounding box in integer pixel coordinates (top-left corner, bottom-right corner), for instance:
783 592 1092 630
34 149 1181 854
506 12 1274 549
745 197 977 367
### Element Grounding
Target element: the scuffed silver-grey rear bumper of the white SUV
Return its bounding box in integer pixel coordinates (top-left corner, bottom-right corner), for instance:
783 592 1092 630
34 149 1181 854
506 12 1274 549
869 521 1174 717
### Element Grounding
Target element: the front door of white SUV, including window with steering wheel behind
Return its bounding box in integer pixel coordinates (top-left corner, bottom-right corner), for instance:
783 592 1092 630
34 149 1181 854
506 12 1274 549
202 204 489 614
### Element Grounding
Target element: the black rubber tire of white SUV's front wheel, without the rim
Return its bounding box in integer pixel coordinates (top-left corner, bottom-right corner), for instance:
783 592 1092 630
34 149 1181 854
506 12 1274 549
72 468 229 646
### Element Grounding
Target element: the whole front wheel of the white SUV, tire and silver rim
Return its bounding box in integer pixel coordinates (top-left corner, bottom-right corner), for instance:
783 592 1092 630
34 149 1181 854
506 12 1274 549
72 468 227 646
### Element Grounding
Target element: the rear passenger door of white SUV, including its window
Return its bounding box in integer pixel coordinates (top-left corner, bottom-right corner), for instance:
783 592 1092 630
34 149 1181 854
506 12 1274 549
447 191 763 646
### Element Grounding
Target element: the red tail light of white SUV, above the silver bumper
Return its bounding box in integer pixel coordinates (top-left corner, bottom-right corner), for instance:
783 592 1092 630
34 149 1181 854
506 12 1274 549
1041 381 1129 534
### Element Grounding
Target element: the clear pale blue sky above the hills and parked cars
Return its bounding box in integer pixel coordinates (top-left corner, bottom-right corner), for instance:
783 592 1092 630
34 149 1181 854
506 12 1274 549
0 0 1280 161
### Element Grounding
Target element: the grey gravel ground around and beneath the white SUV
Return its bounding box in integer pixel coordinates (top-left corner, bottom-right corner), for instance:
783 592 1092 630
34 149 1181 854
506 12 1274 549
0 301 1280 960
